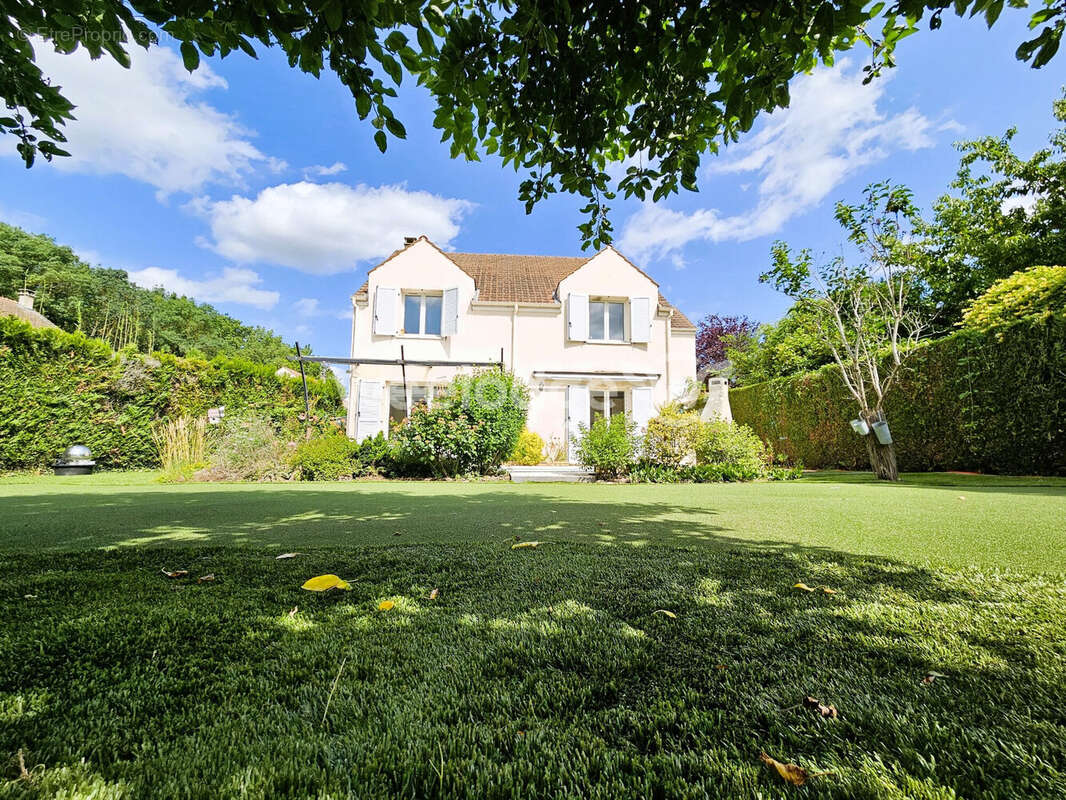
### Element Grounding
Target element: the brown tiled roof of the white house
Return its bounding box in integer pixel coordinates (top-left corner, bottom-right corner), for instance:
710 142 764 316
356 242 696 330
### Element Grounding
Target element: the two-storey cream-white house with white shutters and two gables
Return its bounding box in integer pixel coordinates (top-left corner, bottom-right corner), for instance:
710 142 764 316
348 237 696 457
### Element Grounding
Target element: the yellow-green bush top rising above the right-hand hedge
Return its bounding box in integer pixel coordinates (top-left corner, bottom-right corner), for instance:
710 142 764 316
960 267 1066 331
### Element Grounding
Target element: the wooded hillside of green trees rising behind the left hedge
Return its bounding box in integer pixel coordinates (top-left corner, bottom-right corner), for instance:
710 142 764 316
0 223 313 375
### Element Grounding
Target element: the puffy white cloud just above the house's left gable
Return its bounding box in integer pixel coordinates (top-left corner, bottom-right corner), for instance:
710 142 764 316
190 181 473 275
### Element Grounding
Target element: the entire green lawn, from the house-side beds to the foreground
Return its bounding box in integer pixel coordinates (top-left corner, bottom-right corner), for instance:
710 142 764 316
0 474 1066 800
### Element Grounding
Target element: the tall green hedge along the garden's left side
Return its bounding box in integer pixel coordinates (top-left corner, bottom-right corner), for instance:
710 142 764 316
0 317 343 469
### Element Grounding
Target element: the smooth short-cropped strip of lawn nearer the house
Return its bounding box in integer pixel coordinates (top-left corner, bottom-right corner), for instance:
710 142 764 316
0 473 1066 572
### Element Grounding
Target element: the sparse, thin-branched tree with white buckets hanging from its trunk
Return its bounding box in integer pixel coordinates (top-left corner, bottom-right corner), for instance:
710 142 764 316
760 182 927 481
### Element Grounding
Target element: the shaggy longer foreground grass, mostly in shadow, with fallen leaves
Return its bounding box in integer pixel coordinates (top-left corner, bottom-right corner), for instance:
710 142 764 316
0 542 1066 798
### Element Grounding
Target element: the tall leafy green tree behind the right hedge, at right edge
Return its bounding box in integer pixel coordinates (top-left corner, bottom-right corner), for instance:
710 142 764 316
917 90 1066 329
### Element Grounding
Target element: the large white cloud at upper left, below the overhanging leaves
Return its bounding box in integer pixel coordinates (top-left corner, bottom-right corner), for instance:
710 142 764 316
27 42 285 196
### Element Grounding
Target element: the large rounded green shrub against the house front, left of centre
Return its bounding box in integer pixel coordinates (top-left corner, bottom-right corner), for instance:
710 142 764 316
391 369 529 478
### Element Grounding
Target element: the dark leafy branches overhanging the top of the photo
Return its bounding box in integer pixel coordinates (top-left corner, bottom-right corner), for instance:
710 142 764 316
0 0 1066 246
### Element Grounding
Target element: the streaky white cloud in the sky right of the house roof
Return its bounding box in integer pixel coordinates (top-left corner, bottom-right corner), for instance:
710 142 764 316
618 60 954 259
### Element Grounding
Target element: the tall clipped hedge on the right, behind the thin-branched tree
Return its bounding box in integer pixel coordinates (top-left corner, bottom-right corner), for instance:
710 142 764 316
729 318 1066 475
